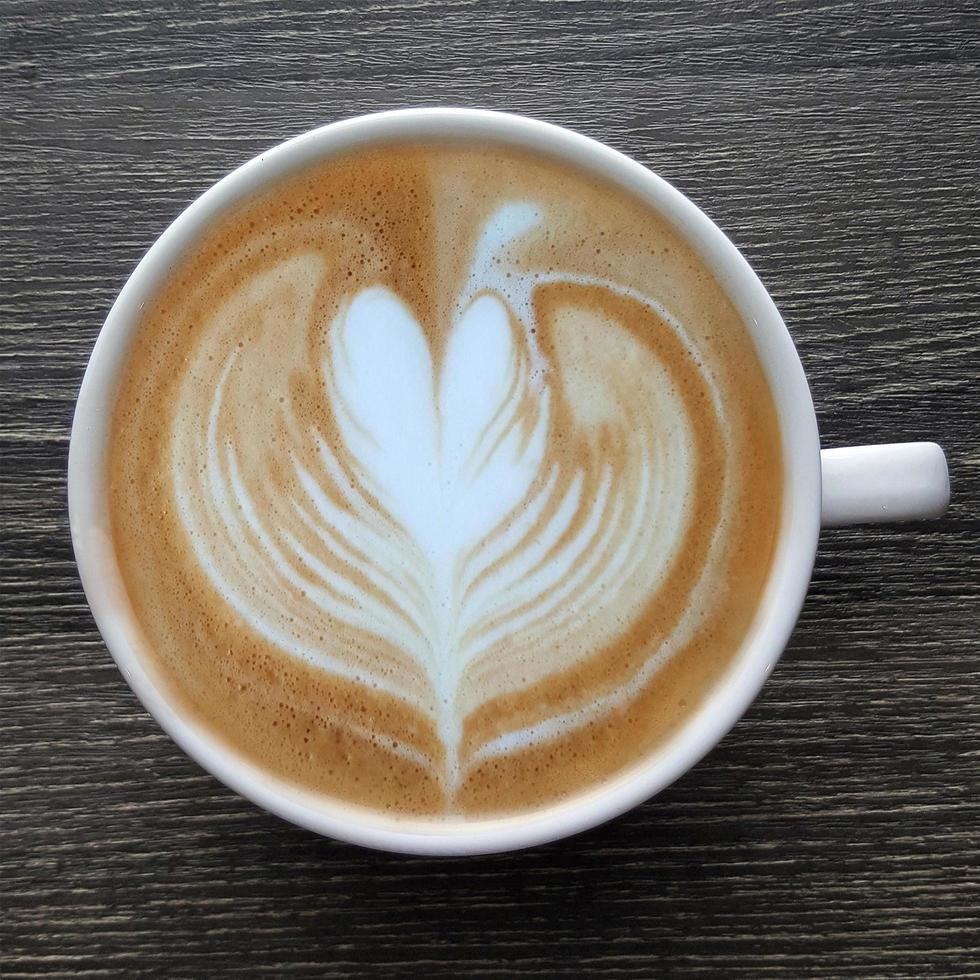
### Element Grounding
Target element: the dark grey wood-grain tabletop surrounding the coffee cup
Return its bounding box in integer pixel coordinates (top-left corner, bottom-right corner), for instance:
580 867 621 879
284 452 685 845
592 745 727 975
0 0 980 978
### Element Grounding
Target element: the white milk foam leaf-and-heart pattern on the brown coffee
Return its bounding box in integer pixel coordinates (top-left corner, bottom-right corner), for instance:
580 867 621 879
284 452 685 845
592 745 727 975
171 201 732 790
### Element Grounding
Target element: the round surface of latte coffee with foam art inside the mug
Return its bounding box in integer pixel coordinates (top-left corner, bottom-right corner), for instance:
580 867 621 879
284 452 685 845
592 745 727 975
108 142 783 818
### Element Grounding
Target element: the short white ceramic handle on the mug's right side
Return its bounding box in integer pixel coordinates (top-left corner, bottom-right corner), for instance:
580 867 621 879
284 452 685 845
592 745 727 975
820 442 949 527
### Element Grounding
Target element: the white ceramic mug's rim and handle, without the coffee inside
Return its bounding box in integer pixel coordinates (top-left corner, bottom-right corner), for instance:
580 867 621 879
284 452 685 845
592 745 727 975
68 109 949 855
